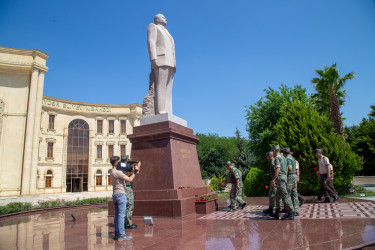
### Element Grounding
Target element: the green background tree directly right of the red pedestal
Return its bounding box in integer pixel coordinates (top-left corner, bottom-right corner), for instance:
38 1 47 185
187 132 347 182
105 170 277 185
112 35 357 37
196 133 237 179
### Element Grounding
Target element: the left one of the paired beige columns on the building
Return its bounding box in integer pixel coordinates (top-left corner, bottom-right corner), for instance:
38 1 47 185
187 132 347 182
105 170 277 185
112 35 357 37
21 68 39 195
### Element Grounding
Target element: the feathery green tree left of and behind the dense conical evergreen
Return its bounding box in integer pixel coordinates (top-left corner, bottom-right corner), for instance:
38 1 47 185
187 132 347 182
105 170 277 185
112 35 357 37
246 84 309 172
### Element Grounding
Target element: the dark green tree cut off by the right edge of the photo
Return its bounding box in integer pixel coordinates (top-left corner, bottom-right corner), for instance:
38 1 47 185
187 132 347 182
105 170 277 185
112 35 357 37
351 114 375 175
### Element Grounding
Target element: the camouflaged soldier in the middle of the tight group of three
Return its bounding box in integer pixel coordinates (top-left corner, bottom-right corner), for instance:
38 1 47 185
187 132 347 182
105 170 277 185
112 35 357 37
272 145 294 220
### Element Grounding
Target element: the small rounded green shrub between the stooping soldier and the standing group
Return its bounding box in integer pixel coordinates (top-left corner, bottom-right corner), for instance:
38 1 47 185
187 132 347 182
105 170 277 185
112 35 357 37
243 168 270 196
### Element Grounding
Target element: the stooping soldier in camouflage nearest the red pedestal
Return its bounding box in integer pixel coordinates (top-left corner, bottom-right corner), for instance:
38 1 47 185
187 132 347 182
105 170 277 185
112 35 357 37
224 161 246 212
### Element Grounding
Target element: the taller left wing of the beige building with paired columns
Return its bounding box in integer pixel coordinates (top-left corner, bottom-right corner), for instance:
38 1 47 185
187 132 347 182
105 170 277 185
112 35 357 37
0 46 49 196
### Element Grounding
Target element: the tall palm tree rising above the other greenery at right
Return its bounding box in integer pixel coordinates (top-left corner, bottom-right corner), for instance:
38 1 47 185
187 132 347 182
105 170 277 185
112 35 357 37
311 63 355 135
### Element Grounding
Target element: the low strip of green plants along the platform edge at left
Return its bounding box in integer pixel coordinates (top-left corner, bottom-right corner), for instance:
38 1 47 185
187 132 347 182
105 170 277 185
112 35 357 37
0 197 112 215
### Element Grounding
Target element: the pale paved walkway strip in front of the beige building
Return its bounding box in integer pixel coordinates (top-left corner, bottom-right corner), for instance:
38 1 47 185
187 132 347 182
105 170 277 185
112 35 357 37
0 191 112 206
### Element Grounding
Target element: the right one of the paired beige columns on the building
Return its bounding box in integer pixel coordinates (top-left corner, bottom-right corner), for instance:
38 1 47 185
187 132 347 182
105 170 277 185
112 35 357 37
29 71 45 194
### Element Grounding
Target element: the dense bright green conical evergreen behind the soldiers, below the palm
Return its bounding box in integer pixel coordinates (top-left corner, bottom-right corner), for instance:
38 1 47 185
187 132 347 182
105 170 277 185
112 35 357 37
276 101 363 195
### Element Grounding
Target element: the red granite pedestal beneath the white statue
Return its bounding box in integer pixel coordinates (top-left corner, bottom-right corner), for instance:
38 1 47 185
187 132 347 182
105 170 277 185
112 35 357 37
128 121 217 217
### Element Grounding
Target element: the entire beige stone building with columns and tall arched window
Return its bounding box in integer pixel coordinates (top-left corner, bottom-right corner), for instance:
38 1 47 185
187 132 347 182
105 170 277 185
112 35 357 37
0 47 142 196
